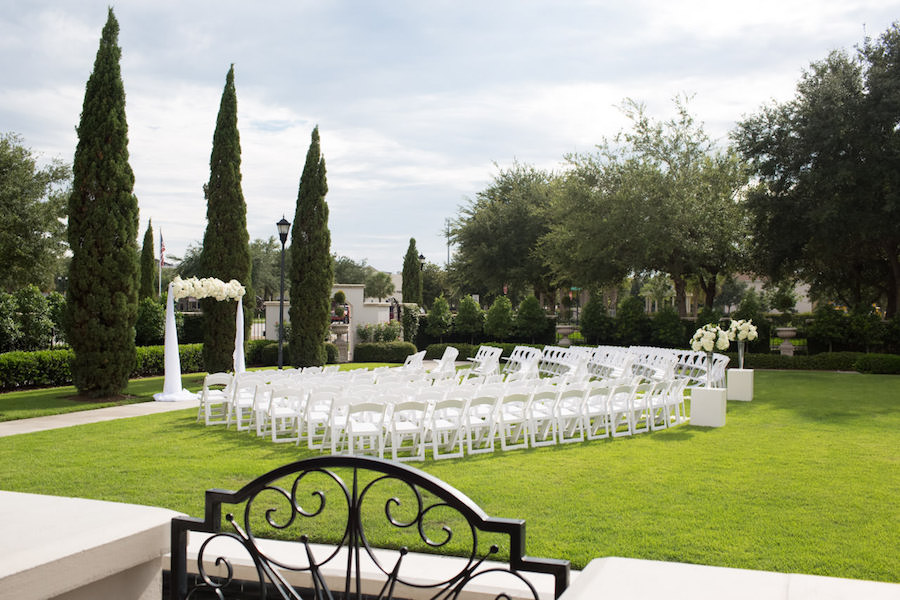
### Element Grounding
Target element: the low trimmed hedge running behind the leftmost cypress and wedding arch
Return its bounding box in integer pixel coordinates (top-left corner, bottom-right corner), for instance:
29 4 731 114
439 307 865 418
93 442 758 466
0 344 203 391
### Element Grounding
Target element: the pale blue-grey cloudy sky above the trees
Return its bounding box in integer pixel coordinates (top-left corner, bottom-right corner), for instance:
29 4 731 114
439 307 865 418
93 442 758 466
0 0 900 271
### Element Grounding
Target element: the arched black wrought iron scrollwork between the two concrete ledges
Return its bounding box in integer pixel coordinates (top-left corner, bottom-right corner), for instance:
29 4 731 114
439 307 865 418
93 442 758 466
170 456 569 600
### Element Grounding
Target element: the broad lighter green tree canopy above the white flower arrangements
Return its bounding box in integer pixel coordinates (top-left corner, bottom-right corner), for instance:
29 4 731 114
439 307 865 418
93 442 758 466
541 98 747 314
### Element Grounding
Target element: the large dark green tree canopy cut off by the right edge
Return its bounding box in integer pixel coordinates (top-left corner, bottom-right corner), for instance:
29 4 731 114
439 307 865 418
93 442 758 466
733 25 900 316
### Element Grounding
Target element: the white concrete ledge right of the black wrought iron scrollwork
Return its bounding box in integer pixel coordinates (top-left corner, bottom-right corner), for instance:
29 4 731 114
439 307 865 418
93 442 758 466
560 557 900 600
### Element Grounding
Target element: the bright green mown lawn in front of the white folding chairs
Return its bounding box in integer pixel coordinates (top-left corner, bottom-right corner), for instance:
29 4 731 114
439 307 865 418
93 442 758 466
0 371 900 582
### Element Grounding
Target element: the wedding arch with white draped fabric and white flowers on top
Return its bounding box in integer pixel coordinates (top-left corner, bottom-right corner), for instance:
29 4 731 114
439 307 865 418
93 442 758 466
153 276 247 402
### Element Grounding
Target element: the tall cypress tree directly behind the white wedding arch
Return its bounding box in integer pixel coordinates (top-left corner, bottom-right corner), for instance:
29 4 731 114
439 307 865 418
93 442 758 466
200 65 254 373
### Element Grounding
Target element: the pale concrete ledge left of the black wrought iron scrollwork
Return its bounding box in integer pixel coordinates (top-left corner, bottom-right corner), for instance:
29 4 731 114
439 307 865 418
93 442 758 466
0 491 179 600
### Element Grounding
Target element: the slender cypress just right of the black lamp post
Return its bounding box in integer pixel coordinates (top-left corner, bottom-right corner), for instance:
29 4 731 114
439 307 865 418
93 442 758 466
289 126 334 367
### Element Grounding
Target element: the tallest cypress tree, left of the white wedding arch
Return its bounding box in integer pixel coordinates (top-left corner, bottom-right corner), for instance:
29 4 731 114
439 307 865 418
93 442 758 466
67 8 139 397
